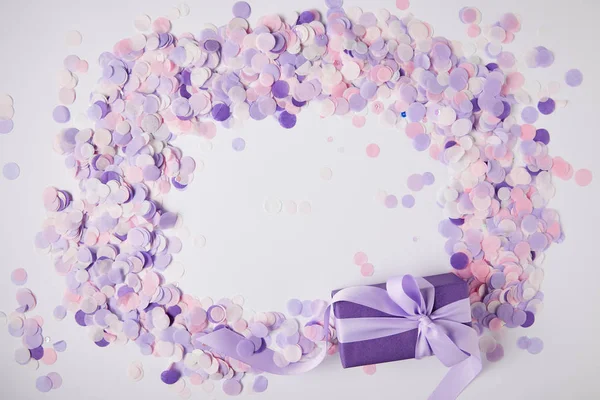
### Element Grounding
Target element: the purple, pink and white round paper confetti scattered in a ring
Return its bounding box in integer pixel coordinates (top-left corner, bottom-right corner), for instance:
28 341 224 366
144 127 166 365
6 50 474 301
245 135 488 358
9 0 576 397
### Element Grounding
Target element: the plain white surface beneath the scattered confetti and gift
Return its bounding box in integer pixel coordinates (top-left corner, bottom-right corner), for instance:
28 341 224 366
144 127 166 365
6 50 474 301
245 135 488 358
0 0 600 400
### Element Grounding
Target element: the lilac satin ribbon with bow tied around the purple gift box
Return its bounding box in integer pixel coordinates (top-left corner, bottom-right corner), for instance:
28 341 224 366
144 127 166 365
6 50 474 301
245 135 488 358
198 275 482 400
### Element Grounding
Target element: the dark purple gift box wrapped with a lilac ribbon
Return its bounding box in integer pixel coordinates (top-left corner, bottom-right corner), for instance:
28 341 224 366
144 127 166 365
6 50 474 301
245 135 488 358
332 273 469 368
